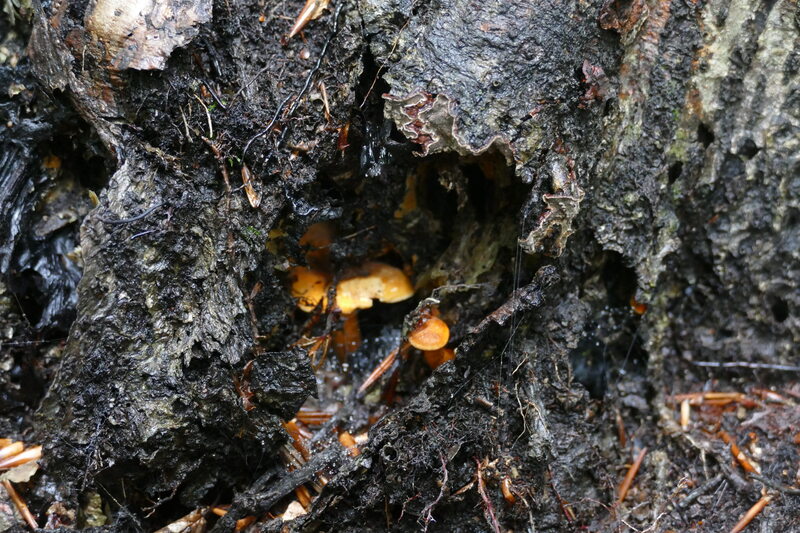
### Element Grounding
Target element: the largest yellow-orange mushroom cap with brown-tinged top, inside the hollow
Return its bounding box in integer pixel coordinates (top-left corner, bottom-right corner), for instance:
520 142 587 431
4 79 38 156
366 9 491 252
336 262 414 314
